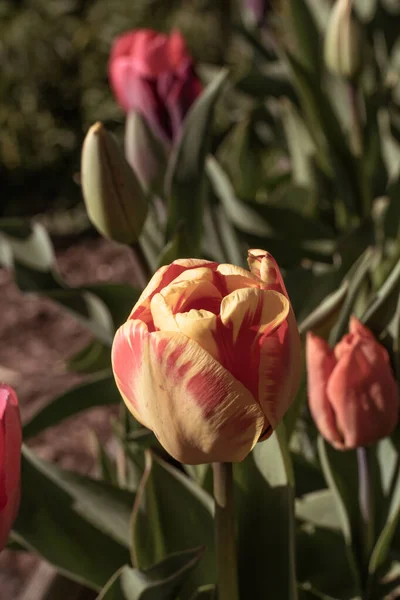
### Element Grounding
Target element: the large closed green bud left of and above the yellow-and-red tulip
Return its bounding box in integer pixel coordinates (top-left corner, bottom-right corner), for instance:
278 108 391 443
81 123 148 244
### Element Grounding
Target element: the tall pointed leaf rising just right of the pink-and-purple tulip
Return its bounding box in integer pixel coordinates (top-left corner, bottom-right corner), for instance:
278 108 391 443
166 70 228 257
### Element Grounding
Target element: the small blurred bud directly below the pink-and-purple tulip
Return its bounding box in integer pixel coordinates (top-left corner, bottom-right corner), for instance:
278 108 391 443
125 110 166 191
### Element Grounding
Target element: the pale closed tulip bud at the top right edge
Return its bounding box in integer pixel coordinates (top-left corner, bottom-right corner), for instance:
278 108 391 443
324 0 362 78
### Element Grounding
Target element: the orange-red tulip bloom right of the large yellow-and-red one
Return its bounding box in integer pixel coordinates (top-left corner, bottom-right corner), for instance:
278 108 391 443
306 317 399 450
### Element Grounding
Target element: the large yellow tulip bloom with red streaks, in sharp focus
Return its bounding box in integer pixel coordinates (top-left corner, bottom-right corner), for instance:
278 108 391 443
112 251 301 464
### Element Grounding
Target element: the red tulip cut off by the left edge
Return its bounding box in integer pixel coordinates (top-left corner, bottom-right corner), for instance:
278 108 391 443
0 385 22 550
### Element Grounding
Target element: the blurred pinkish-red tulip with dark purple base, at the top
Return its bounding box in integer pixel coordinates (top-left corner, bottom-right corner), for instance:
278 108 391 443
109 29 202 145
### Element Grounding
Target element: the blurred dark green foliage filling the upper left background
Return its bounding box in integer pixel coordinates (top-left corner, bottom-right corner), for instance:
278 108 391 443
0 0 238 216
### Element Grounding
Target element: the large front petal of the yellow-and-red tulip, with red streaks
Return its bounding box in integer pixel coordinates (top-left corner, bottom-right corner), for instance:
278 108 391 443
113 321 264 464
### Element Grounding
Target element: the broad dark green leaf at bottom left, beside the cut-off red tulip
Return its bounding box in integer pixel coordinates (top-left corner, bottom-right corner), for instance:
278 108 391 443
13 448 129 590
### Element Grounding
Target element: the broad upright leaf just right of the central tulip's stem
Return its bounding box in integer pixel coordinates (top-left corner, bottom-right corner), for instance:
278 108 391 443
234 427 297 600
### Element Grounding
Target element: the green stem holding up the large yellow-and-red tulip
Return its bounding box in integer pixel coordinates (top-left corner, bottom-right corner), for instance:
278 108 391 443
212 463 239 600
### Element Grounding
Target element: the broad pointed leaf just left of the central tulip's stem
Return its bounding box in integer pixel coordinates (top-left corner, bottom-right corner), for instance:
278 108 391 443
132 451 216 600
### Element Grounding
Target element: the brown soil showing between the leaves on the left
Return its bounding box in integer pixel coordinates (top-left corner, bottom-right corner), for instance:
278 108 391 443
0 239 141 600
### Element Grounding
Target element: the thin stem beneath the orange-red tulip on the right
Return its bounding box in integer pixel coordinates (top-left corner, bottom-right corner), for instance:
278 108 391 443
357 447 375 573
